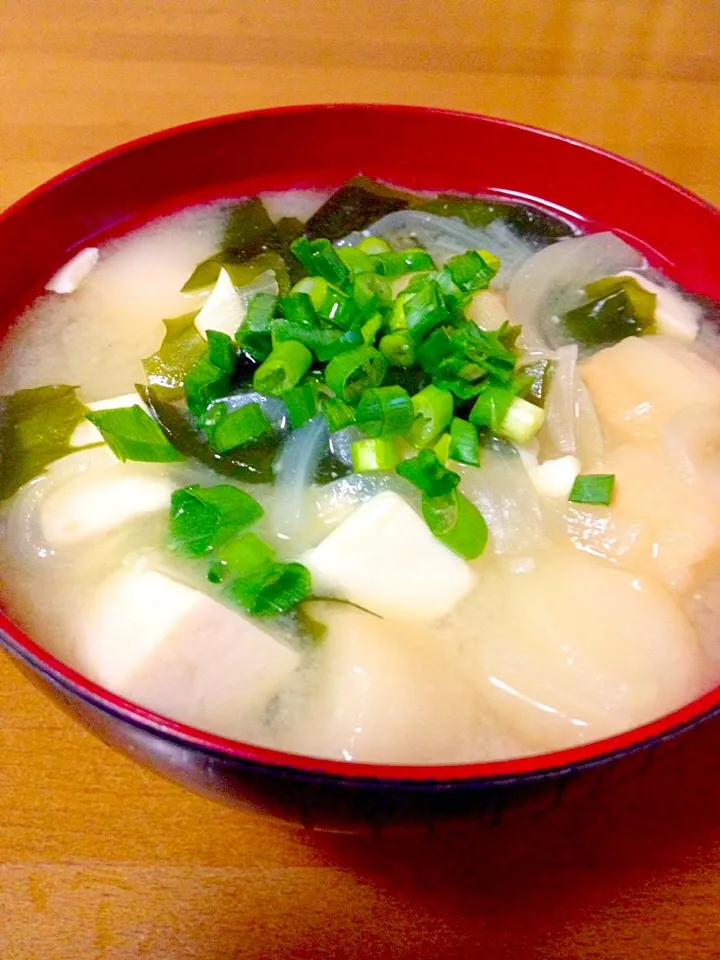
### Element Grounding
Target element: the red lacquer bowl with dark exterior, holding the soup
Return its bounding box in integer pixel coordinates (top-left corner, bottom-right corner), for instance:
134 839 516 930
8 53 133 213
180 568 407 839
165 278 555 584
0 105 720 827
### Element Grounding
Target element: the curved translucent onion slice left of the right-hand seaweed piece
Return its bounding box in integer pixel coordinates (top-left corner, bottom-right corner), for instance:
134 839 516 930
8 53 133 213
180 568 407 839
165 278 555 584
508 233 645 352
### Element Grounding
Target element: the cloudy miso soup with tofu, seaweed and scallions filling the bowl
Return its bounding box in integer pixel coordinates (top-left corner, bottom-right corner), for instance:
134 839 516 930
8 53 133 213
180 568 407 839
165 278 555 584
0 180 720 764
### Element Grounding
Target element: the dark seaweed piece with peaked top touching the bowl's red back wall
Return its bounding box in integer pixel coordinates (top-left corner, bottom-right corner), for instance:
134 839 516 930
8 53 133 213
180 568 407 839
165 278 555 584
305 177 415 240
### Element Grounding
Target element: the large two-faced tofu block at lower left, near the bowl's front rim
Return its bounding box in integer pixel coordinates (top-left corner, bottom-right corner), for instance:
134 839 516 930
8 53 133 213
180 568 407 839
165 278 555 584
78 563 300 737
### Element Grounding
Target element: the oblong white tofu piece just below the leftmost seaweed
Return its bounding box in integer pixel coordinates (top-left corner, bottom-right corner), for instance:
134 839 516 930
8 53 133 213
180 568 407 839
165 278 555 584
39 460 177 549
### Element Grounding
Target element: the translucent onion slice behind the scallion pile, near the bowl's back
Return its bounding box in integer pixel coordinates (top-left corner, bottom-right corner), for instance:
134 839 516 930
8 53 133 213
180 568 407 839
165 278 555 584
336 210 535 287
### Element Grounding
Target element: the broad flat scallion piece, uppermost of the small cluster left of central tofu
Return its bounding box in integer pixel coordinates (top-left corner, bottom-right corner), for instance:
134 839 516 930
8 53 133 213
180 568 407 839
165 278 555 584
170 483 263 557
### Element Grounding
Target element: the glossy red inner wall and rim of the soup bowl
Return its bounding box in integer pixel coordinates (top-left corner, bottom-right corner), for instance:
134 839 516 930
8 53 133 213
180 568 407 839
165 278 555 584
0 105 720 782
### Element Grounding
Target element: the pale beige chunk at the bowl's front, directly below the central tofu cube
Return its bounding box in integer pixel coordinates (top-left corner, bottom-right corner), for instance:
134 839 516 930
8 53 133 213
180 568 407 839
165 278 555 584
283 601 478 763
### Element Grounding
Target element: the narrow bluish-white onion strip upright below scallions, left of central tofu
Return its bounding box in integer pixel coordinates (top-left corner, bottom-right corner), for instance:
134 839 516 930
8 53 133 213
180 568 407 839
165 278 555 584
271 416 329 554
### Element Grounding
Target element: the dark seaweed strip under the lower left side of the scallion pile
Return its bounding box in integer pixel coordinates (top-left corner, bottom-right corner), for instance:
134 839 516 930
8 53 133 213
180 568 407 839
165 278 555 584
136 384 282 483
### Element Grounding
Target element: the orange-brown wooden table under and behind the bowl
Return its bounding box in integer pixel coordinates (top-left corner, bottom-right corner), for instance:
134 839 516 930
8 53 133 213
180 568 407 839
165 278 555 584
0 0 720 960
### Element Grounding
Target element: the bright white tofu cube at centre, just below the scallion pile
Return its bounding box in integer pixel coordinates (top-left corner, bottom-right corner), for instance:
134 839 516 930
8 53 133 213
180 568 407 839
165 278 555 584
302 491 475 621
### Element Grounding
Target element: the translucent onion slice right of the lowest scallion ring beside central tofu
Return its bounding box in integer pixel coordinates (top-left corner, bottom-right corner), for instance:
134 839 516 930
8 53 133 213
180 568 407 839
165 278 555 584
453 441 544 555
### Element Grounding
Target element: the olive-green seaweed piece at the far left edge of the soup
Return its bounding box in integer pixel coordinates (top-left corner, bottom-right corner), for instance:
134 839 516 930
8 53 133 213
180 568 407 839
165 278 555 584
0 384 88 500
